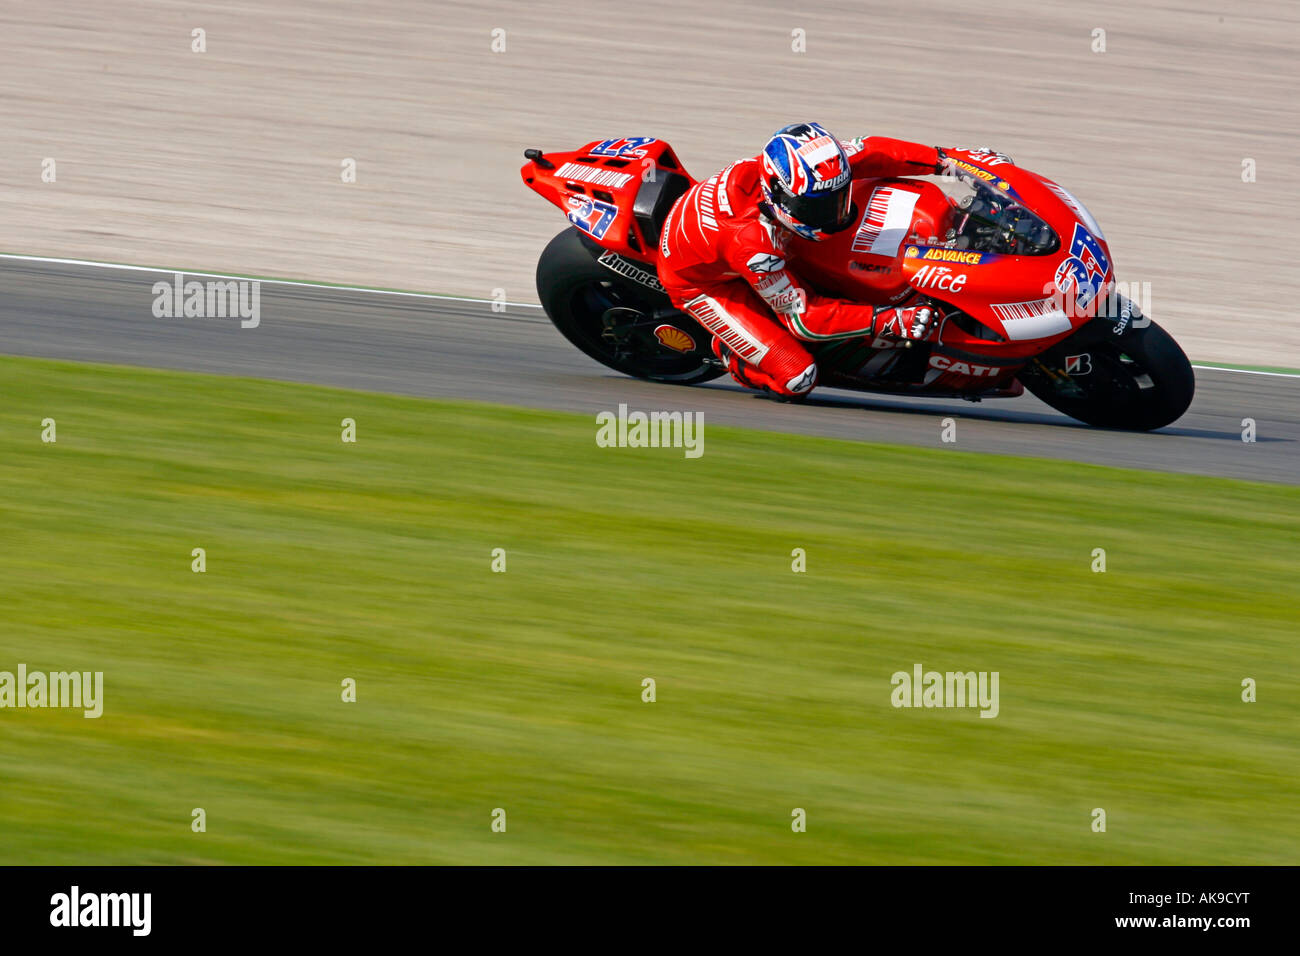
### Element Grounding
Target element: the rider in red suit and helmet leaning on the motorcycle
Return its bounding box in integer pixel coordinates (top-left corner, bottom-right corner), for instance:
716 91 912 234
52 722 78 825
658 122 950 401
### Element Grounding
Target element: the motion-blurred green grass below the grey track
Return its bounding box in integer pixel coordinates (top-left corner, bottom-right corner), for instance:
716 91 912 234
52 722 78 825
0 358 1300 864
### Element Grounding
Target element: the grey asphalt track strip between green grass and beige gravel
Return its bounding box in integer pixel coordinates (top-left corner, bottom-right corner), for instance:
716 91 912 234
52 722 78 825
0 259 1300 484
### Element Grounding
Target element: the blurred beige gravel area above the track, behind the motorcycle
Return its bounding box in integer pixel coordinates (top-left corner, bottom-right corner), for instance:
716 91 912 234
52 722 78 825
0 0 1300 365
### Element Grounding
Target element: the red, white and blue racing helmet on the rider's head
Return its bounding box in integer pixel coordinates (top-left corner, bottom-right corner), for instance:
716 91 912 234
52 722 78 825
761 122 853 242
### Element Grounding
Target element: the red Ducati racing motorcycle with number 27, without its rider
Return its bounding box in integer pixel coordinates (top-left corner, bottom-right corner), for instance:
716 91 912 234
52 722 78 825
521 137 1196 431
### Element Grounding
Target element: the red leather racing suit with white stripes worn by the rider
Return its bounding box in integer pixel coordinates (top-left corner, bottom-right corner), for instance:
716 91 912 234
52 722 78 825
658 137 939 397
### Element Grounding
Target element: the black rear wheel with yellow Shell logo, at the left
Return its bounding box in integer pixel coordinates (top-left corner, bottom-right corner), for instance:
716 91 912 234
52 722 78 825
537 229 724 385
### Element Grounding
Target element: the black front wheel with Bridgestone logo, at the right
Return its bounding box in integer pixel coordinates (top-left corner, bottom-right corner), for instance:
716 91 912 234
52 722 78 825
1019 323 1196 432
